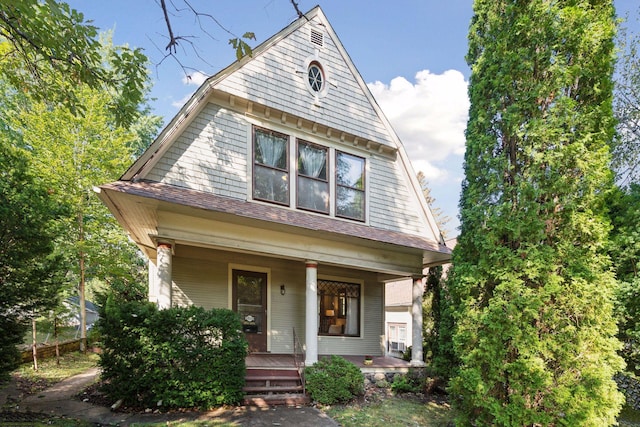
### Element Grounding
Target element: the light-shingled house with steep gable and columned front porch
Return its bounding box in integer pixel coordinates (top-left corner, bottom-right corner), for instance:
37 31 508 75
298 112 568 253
99 7 450 365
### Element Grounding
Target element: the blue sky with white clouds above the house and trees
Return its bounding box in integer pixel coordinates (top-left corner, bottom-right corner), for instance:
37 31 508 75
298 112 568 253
68 0 638 237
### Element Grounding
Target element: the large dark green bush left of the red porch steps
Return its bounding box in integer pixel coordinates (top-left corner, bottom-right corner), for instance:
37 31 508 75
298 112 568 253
97 299 247 408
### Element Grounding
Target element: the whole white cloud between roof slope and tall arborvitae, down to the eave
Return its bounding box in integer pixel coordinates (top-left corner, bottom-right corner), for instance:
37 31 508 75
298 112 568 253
369 70 469 236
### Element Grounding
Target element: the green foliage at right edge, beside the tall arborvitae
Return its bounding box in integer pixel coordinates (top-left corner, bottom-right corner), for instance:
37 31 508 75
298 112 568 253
607 183 640 376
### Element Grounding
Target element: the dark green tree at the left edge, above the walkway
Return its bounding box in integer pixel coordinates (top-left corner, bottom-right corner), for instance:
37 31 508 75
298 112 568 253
0 140 64 381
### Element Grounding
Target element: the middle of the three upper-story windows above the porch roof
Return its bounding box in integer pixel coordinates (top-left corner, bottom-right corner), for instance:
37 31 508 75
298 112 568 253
297 141 330 213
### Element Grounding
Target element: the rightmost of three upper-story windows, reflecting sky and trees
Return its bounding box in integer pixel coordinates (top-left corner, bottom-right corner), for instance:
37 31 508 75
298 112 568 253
336 151 365 221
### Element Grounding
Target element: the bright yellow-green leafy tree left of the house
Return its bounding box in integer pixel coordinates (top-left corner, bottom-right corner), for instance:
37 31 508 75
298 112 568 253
13 86 158 352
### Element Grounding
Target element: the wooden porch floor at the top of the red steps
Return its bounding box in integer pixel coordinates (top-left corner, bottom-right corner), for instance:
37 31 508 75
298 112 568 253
245 353 411 373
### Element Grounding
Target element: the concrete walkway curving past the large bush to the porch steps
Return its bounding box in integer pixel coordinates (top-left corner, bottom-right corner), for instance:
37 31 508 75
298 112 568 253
0 368 339 427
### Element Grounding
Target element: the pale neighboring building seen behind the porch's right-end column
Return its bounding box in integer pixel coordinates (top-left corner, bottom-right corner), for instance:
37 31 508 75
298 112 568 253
385 238 457 358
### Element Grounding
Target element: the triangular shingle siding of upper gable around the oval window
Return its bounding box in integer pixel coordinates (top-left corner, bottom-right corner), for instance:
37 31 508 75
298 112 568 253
215 17 395 150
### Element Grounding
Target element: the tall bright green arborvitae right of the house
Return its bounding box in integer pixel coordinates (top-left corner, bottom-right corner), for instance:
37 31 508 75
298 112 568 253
450 0 622 426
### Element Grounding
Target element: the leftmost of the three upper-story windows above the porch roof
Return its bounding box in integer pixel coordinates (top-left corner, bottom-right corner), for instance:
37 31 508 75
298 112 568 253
253 128 289 206
